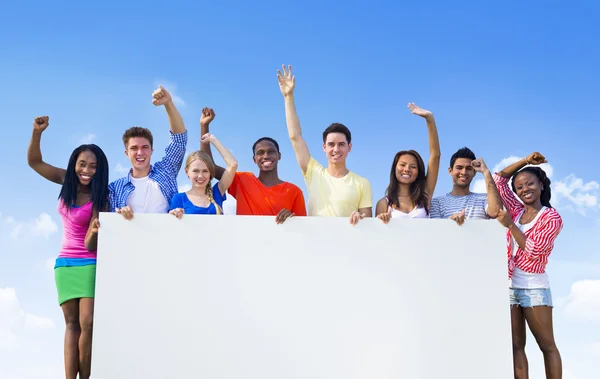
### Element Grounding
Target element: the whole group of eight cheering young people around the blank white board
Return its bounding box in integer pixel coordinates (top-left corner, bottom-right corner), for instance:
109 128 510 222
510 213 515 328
27 66 562 379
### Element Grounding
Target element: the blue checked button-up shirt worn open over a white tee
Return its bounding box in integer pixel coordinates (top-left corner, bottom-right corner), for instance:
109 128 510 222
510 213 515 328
108 130 187 212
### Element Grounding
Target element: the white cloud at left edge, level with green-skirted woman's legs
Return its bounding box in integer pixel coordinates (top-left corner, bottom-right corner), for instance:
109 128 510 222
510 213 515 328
0 287 55 349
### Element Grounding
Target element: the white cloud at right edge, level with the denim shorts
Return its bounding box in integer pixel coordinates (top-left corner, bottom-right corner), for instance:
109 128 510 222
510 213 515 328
565 280 600 322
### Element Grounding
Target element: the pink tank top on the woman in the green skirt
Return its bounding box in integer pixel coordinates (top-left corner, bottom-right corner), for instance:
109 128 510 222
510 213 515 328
58 200 96 259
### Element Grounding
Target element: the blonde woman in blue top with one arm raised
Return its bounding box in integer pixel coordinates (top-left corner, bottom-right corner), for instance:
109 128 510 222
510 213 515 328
169 133 238 219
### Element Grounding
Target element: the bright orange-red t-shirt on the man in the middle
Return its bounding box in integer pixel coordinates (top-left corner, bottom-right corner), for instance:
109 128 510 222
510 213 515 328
227 172 306 216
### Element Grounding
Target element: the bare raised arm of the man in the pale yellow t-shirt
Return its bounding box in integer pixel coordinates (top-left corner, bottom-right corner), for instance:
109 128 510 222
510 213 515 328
277 65 310 174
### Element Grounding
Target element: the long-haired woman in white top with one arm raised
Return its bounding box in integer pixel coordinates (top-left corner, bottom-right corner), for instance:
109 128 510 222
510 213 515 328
375 103 440 224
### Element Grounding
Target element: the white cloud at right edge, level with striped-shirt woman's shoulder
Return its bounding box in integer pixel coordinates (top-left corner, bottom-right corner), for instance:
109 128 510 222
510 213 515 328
552 174 600 216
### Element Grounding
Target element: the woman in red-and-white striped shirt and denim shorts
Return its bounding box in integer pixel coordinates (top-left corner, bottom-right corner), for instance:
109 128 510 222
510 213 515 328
494 153 563 379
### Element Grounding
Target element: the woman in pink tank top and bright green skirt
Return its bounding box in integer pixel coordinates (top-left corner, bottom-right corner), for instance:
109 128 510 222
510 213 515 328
27 116 108 379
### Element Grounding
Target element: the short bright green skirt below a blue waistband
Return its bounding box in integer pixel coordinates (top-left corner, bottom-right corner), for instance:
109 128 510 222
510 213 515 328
54 265 96 305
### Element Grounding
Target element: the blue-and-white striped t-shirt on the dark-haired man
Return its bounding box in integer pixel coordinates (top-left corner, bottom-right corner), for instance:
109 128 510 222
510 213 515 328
429 192 490 220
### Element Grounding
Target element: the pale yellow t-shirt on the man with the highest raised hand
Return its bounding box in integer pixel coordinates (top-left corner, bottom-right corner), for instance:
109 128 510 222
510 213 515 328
304 157 373 217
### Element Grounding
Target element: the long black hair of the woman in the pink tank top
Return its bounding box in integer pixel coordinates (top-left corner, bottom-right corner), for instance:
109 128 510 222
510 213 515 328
58 144 108 212
